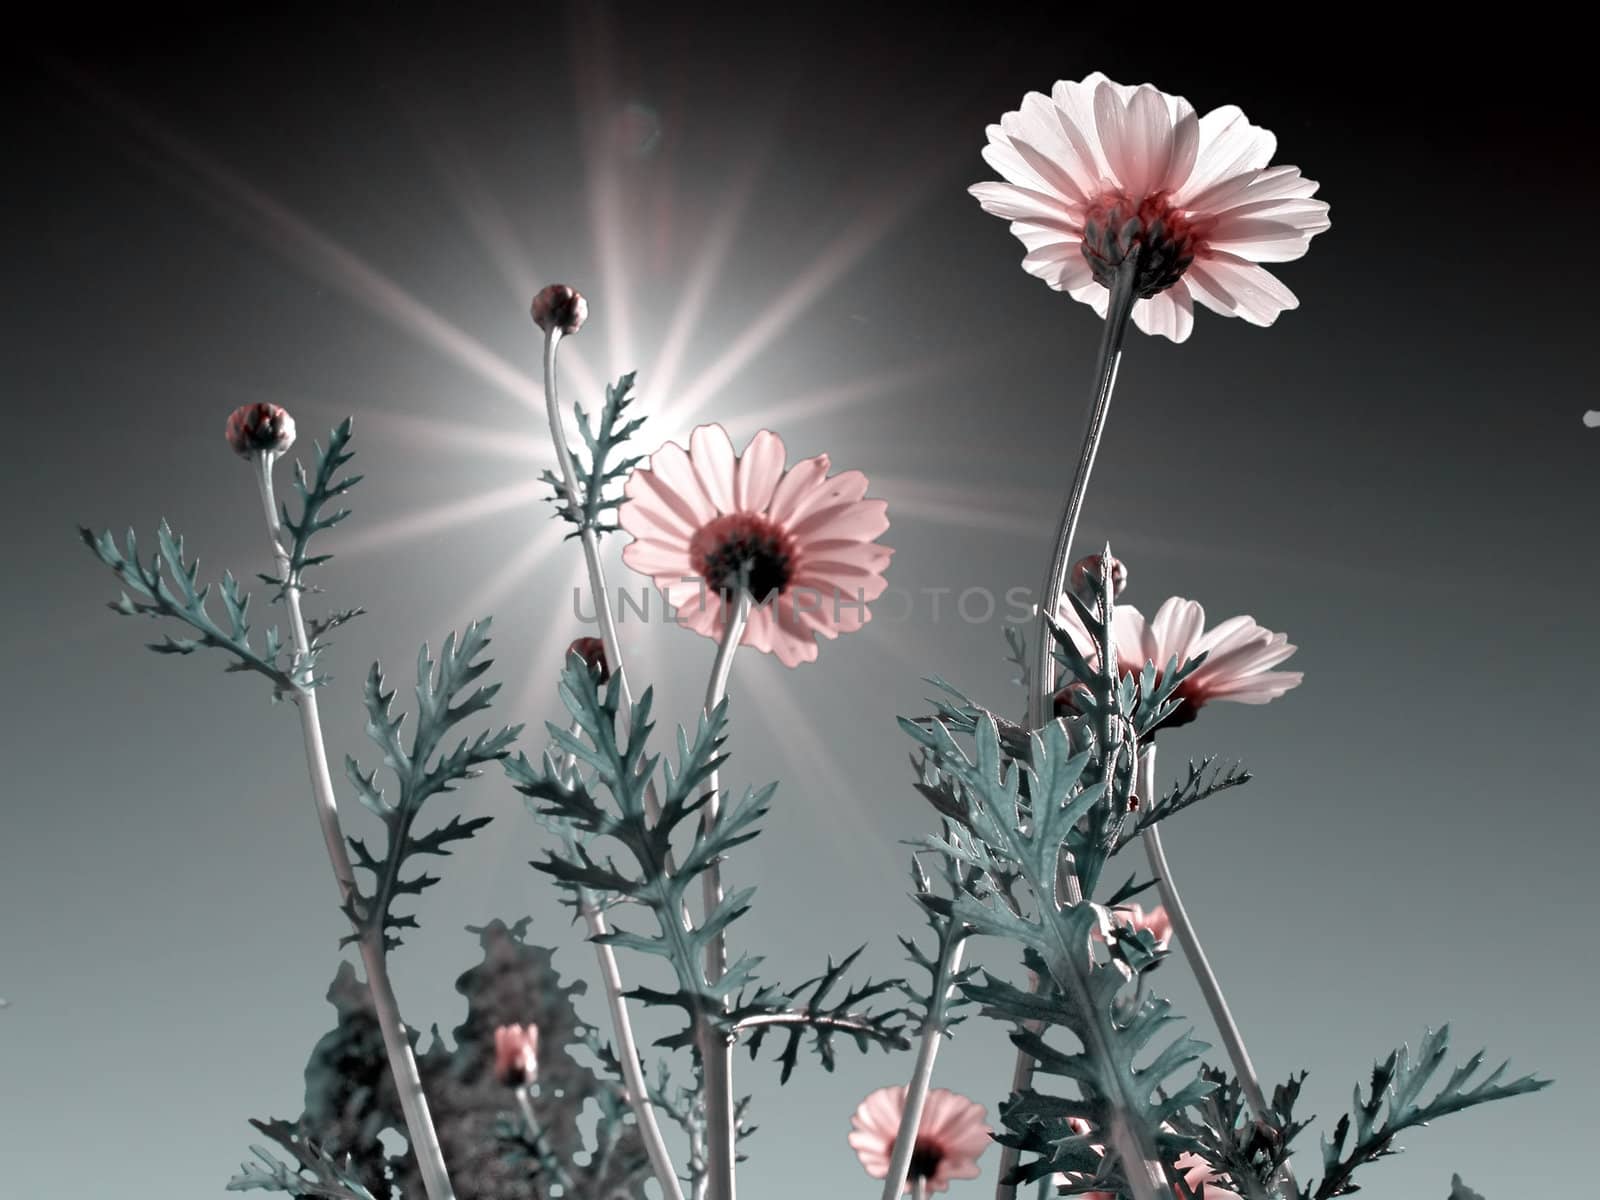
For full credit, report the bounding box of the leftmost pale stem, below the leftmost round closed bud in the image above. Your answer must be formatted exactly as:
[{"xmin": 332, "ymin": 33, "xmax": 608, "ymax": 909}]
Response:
[{"xmin": 256, "ymin": 454, "xmax": 454, "ymax": 1200}]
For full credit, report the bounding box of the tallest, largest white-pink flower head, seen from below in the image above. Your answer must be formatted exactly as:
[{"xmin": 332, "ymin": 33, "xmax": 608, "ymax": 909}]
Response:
[{"xmin": 970, "ymin": 72, "xmax": 1328, "ymax": 342}]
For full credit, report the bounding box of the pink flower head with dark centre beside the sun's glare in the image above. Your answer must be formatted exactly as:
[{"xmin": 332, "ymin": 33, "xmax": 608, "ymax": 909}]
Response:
[{"xmin": 618, "ymin": 426, "xmax": 893, "ymax": 667}]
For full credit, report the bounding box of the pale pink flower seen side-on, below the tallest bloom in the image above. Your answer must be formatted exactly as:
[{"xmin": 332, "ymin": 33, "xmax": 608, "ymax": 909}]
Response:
[{"xmin": 1056, "ymin": 595, "xmax": 1304, "ymax": 730}]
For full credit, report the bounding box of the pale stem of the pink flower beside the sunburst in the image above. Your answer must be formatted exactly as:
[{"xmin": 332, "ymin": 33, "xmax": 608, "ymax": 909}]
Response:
[{"xmin": 696, "ymin": 587, "xmax": 750, "ymax": 1200}]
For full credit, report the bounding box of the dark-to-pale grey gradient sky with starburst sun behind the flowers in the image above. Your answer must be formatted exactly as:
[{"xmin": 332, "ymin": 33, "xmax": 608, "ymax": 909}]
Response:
[{"xmin": 0, "ymin": 16, "xmax": 1600, "ymax": 1200}]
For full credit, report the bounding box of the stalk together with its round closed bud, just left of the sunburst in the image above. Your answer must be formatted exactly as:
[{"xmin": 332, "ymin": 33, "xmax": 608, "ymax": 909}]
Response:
[{"xmin": 533, "ymin": 285, "xmax": 683, "ymax": 1200}]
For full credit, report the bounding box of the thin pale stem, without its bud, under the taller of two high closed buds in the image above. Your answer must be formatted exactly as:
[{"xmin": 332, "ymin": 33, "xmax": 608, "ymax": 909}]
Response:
[{"xmin": 544, "ymin": 325, "xmax": 683, "ymax": 1200}]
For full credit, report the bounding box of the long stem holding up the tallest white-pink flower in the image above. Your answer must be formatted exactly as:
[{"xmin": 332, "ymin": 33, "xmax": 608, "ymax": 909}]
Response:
[{"xmin": 995, "ymin": 254, "xmax": 1139, "ymax": 1200}]
